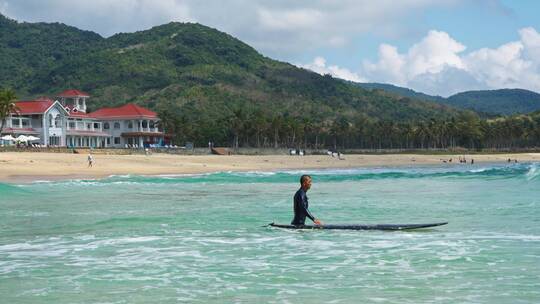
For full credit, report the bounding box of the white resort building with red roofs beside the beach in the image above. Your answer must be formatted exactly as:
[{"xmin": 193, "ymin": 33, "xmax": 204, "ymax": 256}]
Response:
[{"xmin": 1, "ymin": 90, "xmax": 164, "ymax": 148}]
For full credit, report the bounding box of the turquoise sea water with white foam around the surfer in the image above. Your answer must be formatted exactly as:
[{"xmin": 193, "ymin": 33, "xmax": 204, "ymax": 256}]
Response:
[{"xmin": 0, "ymin": 164, "xmax": 540, "ymax": 303}]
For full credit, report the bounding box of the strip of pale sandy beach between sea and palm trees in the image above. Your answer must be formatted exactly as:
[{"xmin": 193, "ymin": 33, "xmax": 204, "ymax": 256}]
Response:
[{"xmin": 0, "ymin": 152, "xmax": 540, "ymax": 183}]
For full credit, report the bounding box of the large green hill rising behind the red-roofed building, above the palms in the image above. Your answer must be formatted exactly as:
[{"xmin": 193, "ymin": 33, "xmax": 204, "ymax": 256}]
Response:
[{"xmin": 0, "ymin": 16, "xmax": 464, "ymax": 145}]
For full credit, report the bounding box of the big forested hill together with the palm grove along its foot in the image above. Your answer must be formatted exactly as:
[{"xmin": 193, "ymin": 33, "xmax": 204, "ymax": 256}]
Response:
[{"xmin": 0, "ymin": 15, "xmax": 540, "ymax": 149}]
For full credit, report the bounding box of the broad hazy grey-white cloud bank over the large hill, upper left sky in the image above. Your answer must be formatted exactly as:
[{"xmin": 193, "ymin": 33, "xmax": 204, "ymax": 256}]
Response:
[{"xmin": 0, "ymin": 0, "xmax": 463, "ymax": 54}]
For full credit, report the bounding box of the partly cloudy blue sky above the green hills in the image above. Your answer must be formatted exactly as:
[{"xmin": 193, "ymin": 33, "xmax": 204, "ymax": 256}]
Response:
[{"xmin": 0, "ymin": 0, "xmax": 540, "ymax": 96}]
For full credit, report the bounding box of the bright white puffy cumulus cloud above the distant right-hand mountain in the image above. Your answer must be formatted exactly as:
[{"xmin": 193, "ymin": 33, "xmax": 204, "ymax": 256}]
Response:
[{"xmin": 362, "ymin": 27, "xmax": 540, "ymax": 96}]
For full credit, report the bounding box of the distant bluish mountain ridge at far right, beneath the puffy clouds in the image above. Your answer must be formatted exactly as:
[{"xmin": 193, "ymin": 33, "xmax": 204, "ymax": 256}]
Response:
[{"xmin": 356, "ymin": 83, "xmax": 540, "ymax": 115}]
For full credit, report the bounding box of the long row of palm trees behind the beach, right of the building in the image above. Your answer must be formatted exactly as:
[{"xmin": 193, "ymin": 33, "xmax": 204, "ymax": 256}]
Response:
[{"xmin": 160, "ymin": 108, "xmax": 540, "ymax": 150}]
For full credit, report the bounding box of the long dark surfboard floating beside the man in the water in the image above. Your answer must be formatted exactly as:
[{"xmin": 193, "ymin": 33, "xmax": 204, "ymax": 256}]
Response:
[{"xmin": 268, "ymin": 222, "xmax": 448, "ymax": 230}]
